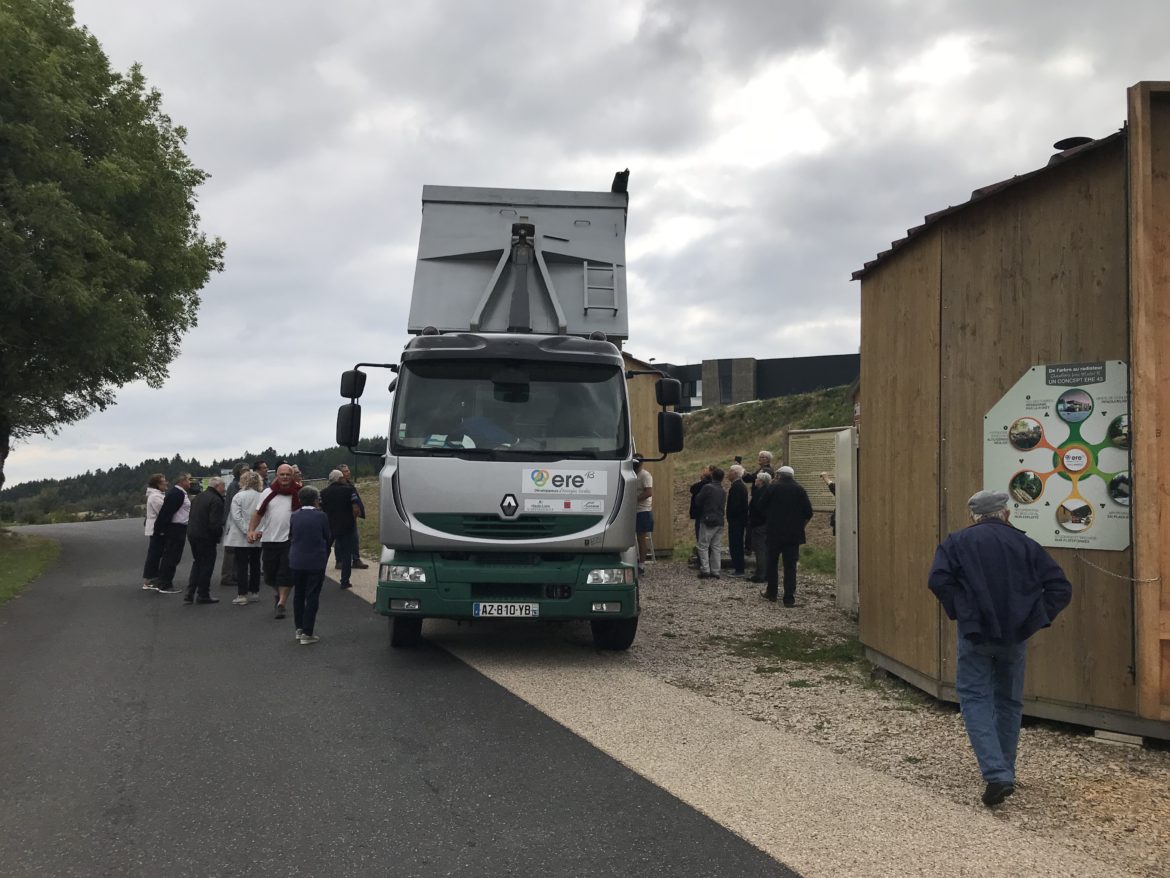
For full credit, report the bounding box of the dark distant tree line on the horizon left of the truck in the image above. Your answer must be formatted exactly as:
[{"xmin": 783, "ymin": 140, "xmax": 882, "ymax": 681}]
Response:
[{"xmin": 0, "ymin": 437, "xmax": 386, "ymax": 524}]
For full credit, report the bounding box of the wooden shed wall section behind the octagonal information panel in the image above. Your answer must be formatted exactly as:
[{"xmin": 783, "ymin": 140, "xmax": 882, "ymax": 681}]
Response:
[{"xmin": 938, "ymin": 139, "xmax": 1135, "ymax": 712}]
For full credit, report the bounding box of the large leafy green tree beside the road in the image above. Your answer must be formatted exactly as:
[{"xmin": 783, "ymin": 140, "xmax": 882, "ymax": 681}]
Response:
[{"xmin": 0, "ymin": 0, "xmax": 223, "ymax": 486}]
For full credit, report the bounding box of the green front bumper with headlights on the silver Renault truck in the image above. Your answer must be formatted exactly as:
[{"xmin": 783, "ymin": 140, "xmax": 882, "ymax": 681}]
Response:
[{"xmin": 374, "ymin": 551, "xmax": 640, "ymax": 619}]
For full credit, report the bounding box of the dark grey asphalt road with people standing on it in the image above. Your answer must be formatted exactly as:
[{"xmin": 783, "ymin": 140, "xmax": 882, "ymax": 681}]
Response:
[{"xmin": 0, "ymin": 521, "xmax": 794, "ymax": 877}]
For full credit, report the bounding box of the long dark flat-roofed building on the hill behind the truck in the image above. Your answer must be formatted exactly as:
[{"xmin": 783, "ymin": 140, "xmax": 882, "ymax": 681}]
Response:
[{"xmin": 658, "ymin": 354, "xmax": 861, "ymax": 411}]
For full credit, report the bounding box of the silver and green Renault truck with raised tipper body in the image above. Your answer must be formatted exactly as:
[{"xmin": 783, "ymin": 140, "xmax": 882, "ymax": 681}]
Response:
[{"xmin": 337, "ymin": 171, "xmax": 683, "ymax": 650}]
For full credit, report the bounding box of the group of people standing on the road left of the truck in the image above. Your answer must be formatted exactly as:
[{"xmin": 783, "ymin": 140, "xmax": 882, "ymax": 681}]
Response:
[{"xmin": 143, "ymin": 460, "xmax": 367, "ymax": 645}]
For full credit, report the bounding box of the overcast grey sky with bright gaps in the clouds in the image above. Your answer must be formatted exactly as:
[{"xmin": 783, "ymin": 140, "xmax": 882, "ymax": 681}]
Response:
[{"xmin": 6, "ymin": 0, "xmax": 1170, "ymax": 485}]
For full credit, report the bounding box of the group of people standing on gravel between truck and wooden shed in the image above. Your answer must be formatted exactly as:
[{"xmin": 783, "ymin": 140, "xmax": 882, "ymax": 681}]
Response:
[{"xmin": 690, "ymin": 451, "xmax": 812, "ymax": 606}]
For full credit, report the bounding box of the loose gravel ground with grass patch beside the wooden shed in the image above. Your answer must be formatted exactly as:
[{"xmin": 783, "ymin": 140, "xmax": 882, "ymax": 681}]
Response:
[{"xmin": 628, "ymin": 557, "xmax": 1170, "ymax": 878}]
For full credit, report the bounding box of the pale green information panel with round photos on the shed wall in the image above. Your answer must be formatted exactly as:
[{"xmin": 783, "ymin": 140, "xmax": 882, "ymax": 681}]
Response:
[{"xmin": 983, "ymin": 359, "xmax": 1130, "ymax": 550}]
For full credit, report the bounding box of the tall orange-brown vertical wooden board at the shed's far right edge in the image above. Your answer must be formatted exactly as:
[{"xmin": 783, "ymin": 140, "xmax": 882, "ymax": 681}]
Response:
[{"xmin": 1129, "ymin": 82, "xmax": 1170, "ymax": 720}]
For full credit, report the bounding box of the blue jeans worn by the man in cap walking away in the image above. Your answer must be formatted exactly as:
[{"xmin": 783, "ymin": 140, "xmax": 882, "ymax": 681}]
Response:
[{"xmin": 955, "ymin": 637, "xmax": 1027, "ymax": 783}]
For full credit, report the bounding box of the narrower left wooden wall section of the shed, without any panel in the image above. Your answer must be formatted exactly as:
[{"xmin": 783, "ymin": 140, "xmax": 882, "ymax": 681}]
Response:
[{"xmin": 858, "ymin": 231, "xmax": 941, "ymax": 679}]
